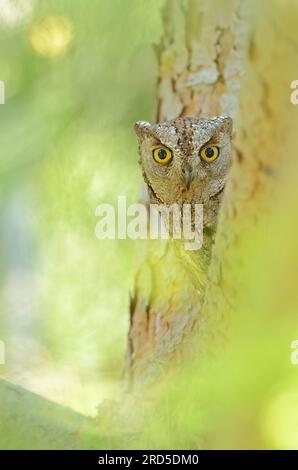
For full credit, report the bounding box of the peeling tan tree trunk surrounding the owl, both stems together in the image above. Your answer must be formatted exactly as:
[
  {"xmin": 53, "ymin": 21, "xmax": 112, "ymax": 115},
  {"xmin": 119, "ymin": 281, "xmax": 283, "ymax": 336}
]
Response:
[{"xmin": 125, "ymin": 0, "xmax": 295, "ymax": 390}]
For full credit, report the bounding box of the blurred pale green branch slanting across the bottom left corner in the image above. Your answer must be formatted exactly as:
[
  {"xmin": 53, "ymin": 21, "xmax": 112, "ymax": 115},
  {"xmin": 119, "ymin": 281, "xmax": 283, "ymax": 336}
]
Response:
[{"xmin": 0, "ymin": 379, "xmax": 98, "ymax": 449}]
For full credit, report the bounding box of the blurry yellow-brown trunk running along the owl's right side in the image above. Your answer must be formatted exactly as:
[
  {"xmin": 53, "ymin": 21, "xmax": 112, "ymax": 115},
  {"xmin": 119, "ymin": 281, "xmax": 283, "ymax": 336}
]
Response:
[{"xmin": 198, "ymin": 0, "xmax": 298, "ymax": 353}]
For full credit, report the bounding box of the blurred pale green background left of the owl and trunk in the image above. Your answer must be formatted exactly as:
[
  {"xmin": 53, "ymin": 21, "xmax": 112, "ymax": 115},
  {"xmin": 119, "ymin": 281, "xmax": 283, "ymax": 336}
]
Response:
[{"xmin": 0, "ymin": 0, "xmax": 162, "ymax": 415}]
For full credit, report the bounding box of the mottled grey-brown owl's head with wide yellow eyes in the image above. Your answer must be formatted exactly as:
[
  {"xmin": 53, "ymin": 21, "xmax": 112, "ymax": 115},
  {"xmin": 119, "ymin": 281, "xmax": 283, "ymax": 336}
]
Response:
[{"xmin": 135, "ymin": 116, "xmax": 233, "ymax": 204}]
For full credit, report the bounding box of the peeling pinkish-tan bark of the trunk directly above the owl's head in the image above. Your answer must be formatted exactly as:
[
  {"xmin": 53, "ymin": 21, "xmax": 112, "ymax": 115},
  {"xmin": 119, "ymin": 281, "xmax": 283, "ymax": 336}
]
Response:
[{"xmin": 157, "ymin": 0, "xmax": 248, "ymax": 121}]
